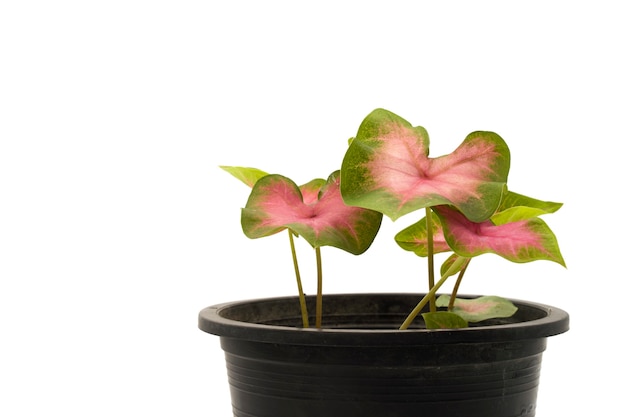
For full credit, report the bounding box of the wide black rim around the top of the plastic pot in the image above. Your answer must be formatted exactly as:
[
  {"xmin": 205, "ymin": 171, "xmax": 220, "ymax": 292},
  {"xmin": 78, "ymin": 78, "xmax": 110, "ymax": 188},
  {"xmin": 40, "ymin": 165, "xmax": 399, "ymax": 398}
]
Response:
[{"xmin": 198, "ymin": 293, "xmax": 569, "ymax": 347}]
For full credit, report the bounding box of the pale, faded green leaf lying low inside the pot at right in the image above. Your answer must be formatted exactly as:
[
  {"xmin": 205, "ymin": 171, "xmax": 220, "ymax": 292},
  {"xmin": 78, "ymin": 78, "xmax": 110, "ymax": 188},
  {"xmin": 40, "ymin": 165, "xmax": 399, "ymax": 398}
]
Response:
[{"xmin": 436, "ymin": 295, "xmax": 517, "ymax": 323}]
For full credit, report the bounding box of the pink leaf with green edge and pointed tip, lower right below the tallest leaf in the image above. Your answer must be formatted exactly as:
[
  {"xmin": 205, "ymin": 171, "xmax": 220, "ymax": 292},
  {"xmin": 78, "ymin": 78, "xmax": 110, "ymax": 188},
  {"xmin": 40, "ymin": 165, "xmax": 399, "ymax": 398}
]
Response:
[{"xmin": 433, "ymin": 206, "xmax": 565, "ymax": 266}]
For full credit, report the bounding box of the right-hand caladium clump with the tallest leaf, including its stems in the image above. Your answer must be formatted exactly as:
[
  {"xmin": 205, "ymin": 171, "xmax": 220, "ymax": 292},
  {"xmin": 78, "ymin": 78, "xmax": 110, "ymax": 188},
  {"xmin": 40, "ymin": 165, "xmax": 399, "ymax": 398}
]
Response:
[{"xmin": 341, "ymin": 109, "xmax": 565, "ymax": 329}]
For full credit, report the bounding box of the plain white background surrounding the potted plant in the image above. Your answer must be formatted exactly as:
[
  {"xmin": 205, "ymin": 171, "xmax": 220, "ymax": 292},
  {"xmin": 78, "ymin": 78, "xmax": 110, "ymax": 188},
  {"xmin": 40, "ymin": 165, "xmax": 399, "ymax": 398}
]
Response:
[{"xmin": 0, "ymin": 0, "xmax": 626, "ymax": 417}]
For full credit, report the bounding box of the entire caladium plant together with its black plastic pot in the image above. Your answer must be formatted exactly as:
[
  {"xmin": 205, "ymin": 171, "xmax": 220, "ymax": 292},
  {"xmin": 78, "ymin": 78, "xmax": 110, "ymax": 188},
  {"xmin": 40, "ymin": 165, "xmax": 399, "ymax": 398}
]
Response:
[{"xmin": 199, "ymin": 109, "xmax": 569, "ymax": 417}]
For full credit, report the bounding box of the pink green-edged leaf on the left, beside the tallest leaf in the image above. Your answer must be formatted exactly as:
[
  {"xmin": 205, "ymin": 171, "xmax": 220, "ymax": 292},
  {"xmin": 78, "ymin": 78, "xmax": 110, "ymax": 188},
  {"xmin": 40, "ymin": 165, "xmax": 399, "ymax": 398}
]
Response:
[{"xmin": 241, "ymin": 171, "xmax": 382, "ymax": 254}]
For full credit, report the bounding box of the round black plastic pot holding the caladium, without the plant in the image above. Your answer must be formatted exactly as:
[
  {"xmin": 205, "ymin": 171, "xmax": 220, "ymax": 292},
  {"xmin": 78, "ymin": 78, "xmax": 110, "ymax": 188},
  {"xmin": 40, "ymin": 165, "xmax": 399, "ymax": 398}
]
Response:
[{"xmin": 198, "ymin": 294, "xmax": 569, "ymax": 417}]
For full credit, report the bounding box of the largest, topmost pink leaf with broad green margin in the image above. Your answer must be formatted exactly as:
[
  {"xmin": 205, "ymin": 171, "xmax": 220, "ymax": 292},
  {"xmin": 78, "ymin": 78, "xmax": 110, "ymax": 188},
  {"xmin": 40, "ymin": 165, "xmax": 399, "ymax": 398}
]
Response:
[{"xmin": 341, "ymin": 109, "xmax": 510, "ymax": 221}]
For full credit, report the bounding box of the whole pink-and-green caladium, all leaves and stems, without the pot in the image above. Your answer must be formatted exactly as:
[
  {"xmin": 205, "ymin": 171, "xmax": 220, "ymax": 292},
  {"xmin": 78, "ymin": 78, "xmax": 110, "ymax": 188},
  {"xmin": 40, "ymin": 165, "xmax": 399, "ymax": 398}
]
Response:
[{"xmin": 222, "ymin": 109, "xmax": 565, "ymax": 329}]
